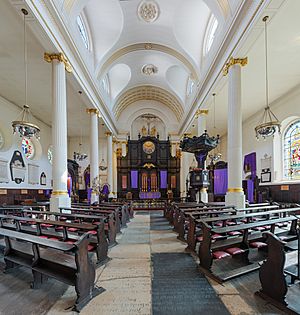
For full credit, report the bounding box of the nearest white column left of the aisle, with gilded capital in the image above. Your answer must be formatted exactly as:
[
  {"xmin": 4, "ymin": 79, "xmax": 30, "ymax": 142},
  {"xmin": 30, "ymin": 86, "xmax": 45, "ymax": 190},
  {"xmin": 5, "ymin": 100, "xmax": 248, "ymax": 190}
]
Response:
[{"xmin": 44, "ymin": 53, "xmax": 72, "ymax": 211}]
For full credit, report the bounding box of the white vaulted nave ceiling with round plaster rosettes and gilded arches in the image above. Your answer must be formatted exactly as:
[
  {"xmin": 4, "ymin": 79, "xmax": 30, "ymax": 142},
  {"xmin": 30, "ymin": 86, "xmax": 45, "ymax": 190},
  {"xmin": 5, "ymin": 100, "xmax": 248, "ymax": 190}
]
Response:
[{"xmin": 57, "ymin": 0, "xmax": 242, "ymax": 135}]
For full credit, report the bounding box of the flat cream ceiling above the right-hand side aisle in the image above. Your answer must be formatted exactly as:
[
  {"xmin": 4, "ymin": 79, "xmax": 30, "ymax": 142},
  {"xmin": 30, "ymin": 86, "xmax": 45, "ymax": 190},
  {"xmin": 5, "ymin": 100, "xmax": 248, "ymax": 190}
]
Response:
[{"xmin": 189, "ymin": 0, "xmax": 300, "ymax": 135}]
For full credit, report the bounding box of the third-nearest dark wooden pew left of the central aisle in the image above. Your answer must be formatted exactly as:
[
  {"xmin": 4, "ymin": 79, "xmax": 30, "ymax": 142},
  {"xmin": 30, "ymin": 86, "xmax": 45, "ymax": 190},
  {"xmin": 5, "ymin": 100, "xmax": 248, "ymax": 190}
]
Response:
[{"xmin": 23, "ymin": 210, "xmax": 117, "ymax": 247}]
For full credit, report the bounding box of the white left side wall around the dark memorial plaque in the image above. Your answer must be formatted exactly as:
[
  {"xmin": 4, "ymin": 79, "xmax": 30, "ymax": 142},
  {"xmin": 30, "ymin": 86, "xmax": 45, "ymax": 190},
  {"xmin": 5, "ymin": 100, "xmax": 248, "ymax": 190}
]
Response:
[{"xmin": 0, "ymin": 96, "xmax": 52, "ymax": 189}]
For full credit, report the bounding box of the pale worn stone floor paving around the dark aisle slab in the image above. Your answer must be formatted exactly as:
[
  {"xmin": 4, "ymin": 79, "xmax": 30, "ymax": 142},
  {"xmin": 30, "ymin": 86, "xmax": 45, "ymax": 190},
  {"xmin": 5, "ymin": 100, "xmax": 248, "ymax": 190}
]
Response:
[{"xmin": 47, "ymin": 211, "xmax": 284, "ymax": 315}]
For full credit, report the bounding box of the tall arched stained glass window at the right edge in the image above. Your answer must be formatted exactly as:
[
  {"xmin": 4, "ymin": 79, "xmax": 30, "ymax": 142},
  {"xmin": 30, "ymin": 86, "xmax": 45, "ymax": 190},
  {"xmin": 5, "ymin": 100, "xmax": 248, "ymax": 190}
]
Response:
[{"xmin": 283, "ymin": 120, "xmax": 300, "ymax": 180}]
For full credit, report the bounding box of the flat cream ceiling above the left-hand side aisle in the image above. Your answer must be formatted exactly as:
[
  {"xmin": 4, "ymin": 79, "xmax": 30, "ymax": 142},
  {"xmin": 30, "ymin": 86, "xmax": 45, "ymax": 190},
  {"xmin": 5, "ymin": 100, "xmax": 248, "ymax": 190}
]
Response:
[{"xmin": 0, "ymin": 1, "xmax": 105, "ymax": 137}]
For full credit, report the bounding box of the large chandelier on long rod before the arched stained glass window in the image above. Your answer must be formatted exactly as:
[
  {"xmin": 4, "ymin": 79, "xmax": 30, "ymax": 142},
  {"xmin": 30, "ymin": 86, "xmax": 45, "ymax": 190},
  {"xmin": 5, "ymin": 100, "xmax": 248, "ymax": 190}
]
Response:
[{"xmin": 255, "ymin": 16, "xmax": 280, "ymax": 140}]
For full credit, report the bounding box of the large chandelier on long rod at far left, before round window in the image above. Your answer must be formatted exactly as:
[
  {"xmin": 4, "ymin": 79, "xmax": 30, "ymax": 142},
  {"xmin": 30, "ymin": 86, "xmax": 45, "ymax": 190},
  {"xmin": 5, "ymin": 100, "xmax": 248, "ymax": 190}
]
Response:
[{"xmin": 11, "ymin": 9, "xmax": 40, "ymax": 139}]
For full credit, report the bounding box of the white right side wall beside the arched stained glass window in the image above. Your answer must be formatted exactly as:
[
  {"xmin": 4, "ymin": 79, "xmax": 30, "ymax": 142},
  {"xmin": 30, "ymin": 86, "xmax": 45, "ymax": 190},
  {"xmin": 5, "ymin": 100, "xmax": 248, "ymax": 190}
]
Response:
[{"xmin": 220, "ymin": 86, "xmax": 300, "ymax": 181}]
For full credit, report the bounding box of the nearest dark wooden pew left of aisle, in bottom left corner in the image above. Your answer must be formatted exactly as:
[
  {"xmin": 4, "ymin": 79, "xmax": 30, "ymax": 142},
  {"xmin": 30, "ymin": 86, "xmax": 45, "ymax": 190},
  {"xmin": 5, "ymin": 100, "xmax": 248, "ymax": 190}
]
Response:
[{"xmin": 0, "ymin": 228, "xmax": 104, "ymax": 312}]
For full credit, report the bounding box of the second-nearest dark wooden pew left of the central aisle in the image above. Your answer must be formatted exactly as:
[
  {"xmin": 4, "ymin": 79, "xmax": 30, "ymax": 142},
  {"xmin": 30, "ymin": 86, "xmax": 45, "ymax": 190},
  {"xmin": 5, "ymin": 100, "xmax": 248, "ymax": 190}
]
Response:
[{"xmin": 0, "ymin": 214, "xmax": 109, "ymax": 266}]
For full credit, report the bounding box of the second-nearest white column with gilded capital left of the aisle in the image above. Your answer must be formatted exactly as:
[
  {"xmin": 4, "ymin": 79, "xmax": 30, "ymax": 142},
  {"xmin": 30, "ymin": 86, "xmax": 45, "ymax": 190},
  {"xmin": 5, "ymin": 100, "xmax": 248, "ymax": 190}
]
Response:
[{"xmin": 87, "ymin": 108, "xmax": 99, "ymax": 203}]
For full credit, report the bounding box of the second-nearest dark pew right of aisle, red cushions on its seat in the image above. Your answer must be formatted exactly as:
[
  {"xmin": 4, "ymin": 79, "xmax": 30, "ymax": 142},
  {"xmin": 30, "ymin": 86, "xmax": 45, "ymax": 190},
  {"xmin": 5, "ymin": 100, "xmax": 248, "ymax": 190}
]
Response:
[{"xmin": 199, "ymin": 215, "xmax": 297, "ymax": 282}]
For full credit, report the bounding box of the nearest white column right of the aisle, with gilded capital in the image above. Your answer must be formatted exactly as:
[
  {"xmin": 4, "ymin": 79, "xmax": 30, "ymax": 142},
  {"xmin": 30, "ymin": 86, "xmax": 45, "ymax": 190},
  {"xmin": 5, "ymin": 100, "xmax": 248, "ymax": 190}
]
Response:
[{"xmin": 224, "ymin": 58, "xmax": 247, "ymax": 208}]
